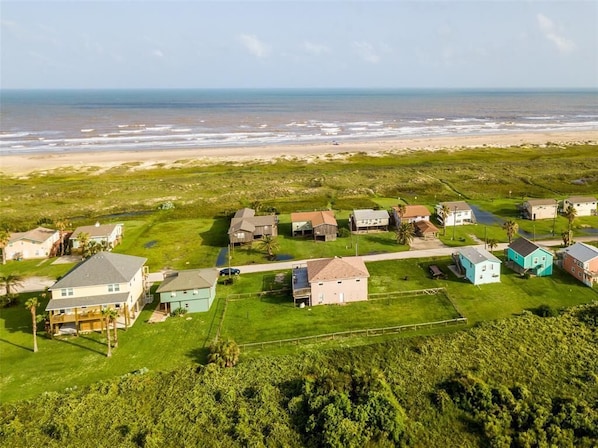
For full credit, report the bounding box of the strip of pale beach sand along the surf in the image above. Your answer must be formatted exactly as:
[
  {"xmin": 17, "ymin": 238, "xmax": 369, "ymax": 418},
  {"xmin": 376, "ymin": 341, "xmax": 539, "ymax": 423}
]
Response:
[{"xmin": 0, "ymin": 131, "xmax": 598, "ymax": 175}]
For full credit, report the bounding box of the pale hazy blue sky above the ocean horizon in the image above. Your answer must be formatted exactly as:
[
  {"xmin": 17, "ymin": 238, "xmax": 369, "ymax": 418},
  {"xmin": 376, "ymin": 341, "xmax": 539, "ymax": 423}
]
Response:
[{"xmin": 0, "ymin": 0, "xmax": 598, "ymax": 89}]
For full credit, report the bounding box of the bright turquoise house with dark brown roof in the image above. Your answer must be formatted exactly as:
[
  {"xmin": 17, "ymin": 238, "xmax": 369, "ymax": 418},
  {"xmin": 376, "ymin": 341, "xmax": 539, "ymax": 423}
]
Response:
[{"xmin": 506, "ymin": 237, "xmax": 554, "ymax": 277}]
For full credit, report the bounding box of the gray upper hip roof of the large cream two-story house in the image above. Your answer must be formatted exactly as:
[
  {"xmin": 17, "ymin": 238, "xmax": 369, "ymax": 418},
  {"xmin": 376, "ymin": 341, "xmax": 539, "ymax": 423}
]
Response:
[{"xmin": 50, "ymin": 252, "xmax": 147, "ymax": 290}]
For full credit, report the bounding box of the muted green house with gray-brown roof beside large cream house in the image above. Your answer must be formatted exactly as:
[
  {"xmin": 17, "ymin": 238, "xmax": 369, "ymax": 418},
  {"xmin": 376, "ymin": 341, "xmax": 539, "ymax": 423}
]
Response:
[{"xmin": 156, "ymin": 269, "xmax": 218, "ymax": 313}]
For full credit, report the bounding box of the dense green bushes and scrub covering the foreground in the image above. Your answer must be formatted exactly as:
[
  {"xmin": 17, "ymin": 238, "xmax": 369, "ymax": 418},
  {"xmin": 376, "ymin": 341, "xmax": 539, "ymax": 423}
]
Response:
[{"xmin": 0, "ymin": 304, "xmax": 598, "ymax": 447}]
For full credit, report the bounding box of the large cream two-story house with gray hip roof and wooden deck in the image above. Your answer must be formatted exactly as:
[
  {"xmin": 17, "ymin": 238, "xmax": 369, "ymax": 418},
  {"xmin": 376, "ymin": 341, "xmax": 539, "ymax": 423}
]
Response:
[{"xmin": 46, "ymin": 252, "xmax": 150, "ymax": 333}]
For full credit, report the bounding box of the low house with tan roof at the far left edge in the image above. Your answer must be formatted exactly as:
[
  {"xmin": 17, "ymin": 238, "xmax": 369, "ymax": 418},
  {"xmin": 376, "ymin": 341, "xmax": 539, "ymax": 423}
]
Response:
[{"xmin": 4, "ymin": 227, "xmax": 60, "ymax": 260}]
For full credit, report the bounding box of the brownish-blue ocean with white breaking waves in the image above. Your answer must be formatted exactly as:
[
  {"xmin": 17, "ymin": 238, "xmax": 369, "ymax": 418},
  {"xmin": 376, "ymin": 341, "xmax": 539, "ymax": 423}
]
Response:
[{"xmin": 0, "ymin": 89, "xmax": 598, "ymax": 154}]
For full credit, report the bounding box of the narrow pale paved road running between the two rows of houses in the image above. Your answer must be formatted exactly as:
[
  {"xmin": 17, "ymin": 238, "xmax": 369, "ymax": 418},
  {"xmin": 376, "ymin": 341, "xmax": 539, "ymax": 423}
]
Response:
[{"xmin": 14, "ymin": 236, "xmax": 598, "ymax": 293}]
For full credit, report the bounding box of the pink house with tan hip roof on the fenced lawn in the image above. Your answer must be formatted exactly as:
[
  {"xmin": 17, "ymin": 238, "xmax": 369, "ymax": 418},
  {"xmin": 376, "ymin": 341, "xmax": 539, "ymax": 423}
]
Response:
[{"xmin": 292, "ymin": 257, "xmax": 370, "ymax": 306}]
